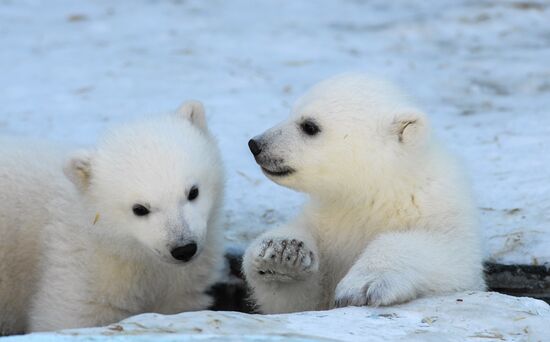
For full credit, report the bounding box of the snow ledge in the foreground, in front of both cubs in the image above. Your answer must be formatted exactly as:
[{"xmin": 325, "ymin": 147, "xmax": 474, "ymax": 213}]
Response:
[{"xmin": 3, "ymin": 292, "xmax": 550, "ymax": 342}]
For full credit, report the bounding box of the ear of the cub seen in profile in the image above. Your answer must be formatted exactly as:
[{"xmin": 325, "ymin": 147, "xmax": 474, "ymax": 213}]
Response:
[{"xmin": 392, "ymin": 111, "xmax": 428, "ymax": 145}]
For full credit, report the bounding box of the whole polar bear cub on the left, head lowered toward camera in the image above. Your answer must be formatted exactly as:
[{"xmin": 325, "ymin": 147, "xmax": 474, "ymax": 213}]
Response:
[{"xmin": 0, "ymin": 102, "xmax": 223, "ymax": 334}]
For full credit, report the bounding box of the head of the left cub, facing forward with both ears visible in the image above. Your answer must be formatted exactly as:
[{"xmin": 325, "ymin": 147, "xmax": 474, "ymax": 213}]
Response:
[{"xmin": 65, "ymin": 101, "xmax": 223, "ymax": 263}]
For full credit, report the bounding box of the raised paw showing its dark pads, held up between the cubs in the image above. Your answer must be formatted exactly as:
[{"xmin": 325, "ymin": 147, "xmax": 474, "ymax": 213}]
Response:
[{"xmin": 246, "ymin": 238, "xmax": 318, "ymax": 282}]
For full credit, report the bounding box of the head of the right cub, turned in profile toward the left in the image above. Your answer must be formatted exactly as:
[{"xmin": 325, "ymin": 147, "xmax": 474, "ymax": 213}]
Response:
[{"xmin": 249, "ymin": 74, "xmax": 436, "ymax": 198}]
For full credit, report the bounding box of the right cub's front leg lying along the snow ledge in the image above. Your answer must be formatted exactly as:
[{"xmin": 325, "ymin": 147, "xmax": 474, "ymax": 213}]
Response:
[{"xmin": 335, "ymin": 231, "xmax": 485, "ymax": 307}]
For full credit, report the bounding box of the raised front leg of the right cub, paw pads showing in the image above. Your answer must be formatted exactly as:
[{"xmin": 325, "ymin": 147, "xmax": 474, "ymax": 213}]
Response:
[{"xmin": 243, "ymin": 223, "xmax": 321, "ymax": 313}]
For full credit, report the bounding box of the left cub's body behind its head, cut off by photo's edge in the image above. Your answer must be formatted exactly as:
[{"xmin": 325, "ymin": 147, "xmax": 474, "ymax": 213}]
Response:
[{"xmin": 0, "ymin": 137, "xmax": 73, "ymax": 335}]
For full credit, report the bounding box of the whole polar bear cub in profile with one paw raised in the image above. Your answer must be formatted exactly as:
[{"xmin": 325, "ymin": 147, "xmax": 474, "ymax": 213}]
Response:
[{"xmin": 243, "ymin": 74, "xmax": 485, "ymax": 313}]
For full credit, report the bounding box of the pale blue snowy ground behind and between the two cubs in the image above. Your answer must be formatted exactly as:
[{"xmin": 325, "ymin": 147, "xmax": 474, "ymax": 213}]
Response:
[{"xmin": 0, "ymin": 0, "xmax": 550, "ymax": 264}]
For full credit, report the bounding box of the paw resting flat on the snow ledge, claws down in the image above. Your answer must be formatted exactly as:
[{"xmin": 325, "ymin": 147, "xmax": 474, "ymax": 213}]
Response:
[{"xmin": 334, "ymin": 271, "xmax": 416, "ymax": 307}]
